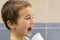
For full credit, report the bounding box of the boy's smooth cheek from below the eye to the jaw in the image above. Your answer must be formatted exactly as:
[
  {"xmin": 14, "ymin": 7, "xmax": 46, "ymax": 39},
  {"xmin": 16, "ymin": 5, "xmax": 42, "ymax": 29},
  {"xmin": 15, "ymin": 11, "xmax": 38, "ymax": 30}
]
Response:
[{"xmin": 16, "ymin": 20, "xmax": 29, "ymax": 34}]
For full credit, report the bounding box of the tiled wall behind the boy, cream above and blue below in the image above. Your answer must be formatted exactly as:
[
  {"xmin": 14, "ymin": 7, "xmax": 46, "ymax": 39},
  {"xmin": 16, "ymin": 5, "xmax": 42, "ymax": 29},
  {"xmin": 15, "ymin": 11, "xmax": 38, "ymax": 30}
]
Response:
[{"xmin": 0, "ymin": 0, "xmax": 60, "ymax": 40}]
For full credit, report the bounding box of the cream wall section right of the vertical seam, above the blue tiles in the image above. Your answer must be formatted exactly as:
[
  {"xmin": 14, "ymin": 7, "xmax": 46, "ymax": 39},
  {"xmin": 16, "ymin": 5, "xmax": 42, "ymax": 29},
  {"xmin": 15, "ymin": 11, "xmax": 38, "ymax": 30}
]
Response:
[{"xmin": 47, "ymin": 0, "xmax": 60, "ymax": 23}]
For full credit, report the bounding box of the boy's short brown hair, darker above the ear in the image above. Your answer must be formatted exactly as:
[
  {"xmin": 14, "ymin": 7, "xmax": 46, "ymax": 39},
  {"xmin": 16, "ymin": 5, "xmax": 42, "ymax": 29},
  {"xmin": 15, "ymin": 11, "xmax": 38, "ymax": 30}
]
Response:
[{"xmin": 1, "ymin": 1, "xmax": 31, "ymax": 29}]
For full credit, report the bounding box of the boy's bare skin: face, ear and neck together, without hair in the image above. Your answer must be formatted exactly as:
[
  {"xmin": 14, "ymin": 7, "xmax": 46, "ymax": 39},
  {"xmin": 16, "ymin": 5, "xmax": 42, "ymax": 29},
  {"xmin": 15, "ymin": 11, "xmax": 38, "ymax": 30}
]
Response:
[{"xmin": 7, "ymin": 7, "xmax": 34, "ymax": 40}]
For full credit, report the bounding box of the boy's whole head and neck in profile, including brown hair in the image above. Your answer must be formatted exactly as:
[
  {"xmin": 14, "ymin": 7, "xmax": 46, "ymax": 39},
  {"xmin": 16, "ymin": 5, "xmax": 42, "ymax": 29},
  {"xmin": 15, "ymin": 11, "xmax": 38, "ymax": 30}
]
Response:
[{"xmin": 1, "ymin": 0, "xmax": 34, "ymax": 40}]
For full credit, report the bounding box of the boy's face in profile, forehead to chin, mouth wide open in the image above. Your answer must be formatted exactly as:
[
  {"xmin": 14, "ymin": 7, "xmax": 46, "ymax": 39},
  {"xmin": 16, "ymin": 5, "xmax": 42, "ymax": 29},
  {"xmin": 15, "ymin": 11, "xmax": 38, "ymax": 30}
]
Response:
[{"xmin": 15, "ymin": 7, "xmax": 34, "ymax": 36}]
